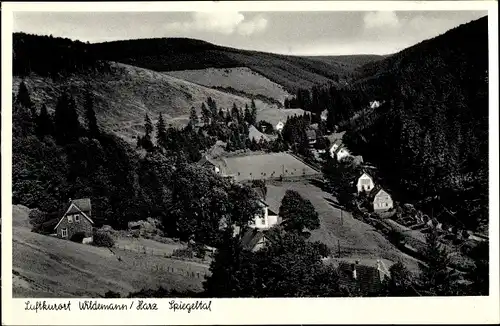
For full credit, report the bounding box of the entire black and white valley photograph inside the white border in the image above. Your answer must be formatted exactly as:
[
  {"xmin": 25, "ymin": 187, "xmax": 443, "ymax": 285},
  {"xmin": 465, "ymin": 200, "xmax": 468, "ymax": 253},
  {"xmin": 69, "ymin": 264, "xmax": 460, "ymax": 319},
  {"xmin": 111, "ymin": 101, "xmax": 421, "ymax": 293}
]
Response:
[{"xmin": 2, "ymin": 0, "xmax": 498, "ymax": 314}]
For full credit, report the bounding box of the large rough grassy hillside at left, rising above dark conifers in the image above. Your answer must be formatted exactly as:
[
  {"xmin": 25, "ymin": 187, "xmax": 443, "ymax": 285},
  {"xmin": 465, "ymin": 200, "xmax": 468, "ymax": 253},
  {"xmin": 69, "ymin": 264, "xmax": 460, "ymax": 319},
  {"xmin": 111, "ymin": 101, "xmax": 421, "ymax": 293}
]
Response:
[{"xmin": 13, "ymin": 64, "xmax": 275, "ymax": 142}]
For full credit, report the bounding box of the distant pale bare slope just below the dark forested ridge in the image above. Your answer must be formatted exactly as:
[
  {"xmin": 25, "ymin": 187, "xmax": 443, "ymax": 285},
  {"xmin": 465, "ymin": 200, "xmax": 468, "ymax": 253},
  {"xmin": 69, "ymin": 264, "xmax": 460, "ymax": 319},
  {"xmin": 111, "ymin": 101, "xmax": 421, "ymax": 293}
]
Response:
[{"xmin": 166, "ymin": 67, "xmax": 290, "ymax": 103}]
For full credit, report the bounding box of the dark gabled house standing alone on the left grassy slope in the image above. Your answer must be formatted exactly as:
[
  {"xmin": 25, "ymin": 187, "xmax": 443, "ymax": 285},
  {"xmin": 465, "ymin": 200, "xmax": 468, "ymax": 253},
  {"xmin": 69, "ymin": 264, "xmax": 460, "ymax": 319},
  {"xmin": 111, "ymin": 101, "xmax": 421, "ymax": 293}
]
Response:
[{"xmin": 54, "ymin": 198, "xmax": 94, "ymax": 243}]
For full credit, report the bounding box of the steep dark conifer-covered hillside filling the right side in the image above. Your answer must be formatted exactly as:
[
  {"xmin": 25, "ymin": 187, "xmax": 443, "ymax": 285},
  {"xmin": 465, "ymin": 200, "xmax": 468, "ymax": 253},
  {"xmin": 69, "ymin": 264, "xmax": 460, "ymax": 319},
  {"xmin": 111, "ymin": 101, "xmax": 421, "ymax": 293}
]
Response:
[{"xmin": 297, "ymin": 17, "xmax": 488, "ymax": 232}]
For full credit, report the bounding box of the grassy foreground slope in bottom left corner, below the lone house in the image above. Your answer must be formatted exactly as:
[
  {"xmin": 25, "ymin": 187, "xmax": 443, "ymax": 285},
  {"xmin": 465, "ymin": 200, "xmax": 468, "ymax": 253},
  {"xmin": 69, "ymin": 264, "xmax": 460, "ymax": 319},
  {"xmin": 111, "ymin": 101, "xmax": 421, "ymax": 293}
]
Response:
[{"xmin": 12, "ymin": 206, "xmax": 207, "ymax": 297}]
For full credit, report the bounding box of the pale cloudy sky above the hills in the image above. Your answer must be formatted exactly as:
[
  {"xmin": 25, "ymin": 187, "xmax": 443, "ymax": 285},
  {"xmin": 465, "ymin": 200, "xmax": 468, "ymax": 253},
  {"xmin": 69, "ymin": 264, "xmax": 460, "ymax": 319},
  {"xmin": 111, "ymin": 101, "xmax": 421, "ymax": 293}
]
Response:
[{"xmin": 14, "ymin": 11, "xmax": 487, "ymax": 55}]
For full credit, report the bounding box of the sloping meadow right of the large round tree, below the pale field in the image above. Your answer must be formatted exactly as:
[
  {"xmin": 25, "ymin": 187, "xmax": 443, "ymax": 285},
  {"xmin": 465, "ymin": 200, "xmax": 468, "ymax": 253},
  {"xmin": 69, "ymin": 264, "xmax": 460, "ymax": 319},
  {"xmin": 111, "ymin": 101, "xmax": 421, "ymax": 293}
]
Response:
[{"xmin": 266, "ymin": 182, "xmax": 418, "ymax": 271}]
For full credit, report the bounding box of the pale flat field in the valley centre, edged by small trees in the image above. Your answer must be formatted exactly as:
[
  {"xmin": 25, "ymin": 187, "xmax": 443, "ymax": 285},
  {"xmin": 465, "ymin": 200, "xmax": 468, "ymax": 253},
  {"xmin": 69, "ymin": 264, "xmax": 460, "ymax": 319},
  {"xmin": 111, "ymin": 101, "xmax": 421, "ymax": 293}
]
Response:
[{"xmin": 219, "ymin": 153, "xmax": 319, "ymax": 181}]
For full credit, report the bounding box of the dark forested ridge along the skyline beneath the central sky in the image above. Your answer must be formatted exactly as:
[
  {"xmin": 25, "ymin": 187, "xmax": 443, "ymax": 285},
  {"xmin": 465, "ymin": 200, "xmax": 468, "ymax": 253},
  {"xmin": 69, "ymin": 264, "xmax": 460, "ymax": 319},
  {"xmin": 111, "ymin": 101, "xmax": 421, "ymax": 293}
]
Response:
[{"xmin": 91, "ymin": 38, "xmax": 356, "ymax": 92}]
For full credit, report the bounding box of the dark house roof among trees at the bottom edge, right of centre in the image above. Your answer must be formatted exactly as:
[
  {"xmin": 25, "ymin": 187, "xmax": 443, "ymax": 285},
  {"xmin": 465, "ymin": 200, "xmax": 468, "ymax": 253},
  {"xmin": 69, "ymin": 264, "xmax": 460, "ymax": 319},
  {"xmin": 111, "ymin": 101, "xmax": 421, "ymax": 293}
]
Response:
[{"xmin": 338, "ymin": 262, "xmax": 382, "ymax": 294}]
